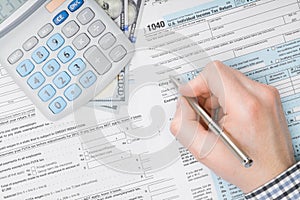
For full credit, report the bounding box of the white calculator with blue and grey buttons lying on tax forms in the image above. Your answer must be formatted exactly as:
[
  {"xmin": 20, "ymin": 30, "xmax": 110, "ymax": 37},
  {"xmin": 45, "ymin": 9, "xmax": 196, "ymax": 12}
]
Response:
[{"xmin": 0, "ymin": 0, "xmax": 134, "ymax": 120}]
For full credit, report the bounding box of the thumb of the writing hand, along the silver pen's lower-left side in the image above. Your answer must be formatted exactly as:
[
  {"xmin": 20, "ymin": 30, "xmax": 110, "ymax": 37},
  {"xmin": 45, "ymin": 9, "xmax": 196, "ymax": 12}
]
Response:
[{"xmin": 171, "ymin": 95, "xmax": 244, "ymax": 170}]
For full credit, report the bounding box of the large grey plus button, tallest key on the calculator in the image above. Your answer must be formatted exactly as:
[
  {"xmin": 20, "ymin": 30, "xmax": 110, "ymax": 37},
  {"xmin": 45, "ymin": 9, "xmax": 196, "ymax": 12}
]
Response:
[{"xmin": 83, "ymin": 46, "xmax": 112, "ymax": 75}]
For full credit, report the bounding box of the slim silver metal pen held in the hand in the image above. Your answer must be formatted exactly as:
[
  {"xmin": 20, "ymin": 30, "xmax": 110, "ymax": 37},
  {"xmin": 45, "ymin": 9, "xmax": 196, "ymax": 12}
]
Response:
[{"xmin": 170, "ymin": 76, "xmax": 253, "ymax": 168}]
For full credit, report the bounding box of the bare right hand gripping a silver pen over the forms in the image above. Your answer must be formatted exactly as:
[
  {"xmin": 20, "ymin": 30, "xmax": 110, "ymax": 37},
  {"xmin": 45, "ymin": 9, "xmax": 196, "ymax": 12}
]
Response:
[{"xmin": 171, "ymin": 61, "xmax": 295, "ymax": 193}]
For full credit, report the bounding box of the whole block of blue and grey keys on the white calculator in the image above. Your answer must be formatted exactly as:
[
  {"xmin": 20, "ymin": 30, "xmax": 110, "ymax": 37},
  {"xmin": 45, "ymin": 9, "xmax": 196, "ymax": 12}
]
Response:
[{"xmin": 7, "ymin": 0, "xmax": 131, "ymax": 117}]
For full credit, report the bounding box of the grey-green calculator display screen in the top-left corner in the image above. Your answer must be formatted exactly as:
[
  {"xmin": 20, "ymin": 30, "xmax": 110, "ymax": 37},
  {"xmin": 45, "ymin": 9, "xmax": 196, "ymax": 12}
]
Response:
[{"xmin": 0, "ymin": 0, "xmax": 27, "ymax": 24}]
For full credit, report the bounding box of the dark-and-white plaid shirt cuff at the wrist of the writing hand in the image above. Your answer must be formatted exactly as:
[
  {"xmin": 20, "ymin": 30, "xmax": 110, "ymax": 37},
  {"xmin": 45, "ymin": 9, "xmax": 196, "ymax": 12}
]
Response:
[{"xmin": 245, "ymin": 162, "xmax": 300, "ymax": 200}]
